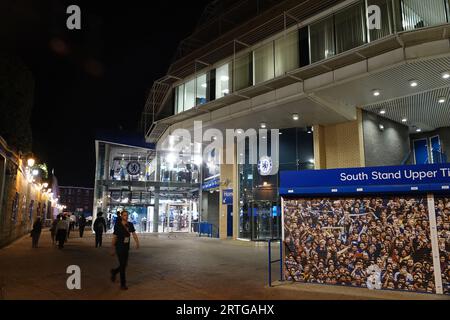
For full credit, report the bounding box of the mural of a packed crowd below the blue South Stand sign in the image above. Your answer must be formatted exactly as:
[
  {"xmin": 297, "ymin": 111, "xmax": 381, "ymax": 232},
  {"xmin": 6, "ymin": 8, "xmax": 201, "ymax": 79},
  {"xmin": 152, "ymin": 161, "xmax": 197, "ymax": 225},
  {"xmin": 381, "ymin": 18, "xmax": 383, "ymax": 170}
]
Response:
[{"xmin": 284, "ymin": 196, "xmax": 450, "ymax": 294}]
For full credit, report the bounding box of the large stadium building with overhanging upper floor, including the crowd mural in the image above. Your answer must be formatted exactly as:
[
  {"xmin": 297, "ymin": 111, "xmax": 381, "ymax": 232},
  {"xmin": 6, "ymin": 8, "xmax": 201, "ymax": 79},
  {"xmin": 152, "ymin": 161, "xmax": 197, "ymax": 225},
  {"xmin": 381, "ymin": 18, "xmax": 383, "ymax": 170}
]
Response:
[{"xmin": 136, "ymin": 0, "xmax": 450, "ymax": 293}]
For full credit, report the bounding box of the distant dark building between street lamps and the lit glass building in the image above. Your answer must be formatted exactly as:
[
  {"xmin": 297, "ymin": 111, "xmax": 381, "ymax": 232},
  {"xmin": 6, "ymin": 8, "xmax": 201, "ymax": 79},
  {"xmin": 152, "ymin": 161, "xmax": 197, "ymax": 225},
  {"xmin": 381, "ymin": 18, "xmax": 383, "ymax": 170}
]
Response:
[{"xmin": 59, "ymin": 186, "xmax": 94, "ymax": 216}]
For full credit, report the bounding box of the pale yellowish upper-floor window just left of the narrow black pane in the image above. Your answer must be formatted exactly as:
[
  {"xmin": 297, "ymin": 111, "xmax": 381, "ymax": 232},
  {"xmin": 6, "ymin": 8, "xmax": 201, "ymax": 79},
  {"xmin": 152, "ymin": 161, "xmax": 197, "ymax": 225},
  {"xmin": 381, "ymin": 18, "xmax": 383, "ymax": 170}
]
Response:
[{"xmin": 275, "ymin": 31, "xmax": 299, "ymax": 77}]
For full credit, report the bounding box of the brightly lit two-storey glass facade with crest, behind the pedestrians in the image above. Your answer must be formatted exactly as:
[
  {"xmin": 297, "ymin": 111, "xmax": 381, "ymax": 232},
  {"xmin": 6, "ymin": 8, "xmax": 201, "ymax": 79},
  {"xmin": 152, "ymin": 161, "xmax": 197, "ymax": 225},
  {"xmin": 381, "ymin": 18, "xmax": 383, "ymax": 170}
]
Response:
[{"xmin": 94, "ymin": 141, "xmax": 199, "ymax": 232}]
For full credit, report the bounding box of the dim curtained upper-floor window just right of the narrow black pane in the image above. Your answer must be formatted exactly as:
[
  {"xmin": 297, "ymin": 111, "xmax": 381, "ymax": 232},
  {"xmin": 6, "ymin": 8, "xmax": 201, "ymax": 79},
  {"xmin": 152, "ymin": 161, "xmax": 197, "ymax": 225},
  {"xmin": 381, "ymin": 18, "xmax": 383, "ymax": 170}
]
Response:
[{"xmin": 309, "ymin": 16, "xmax": 335, "ymax": 63}]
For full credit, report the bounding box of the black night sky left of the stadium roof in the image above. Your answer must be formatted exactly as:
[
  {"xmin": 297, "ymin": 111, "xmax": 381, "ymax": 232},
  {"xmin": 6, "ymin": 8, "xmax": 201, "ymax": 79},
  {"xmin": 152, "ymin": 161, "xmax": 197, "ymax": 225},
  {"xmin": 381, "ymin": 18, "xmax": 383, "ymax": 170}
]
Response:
[{"xmin": 0, "ymin": 0, "xmax": 210, "ymax": 187}]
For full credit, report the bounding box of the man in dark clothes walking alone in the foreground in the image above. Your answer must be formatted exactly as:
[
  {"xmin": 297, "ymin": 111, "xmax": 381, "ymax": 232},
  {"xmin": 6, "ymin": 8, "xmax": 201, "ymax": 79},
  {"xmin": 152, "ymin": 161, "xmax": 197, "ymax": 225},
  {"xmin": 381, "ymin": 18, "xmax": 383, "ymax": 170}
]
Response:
[{"xmin": 111, "ymin": 211, "xmax": 139, "ymax": 290}]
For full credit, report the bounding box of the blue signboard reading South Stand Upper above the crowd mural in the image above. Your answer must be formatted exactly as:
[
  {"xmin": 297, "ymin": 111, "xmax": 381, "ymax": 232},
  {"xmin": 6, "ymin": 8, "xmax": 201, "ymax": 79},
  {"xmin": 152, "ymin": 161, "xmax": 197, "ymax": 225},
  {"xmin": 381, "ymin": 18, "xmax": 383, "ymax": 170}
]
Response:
[{"xmin": 280, "ymin": 163, "xmax": 450, "ymax": 195}]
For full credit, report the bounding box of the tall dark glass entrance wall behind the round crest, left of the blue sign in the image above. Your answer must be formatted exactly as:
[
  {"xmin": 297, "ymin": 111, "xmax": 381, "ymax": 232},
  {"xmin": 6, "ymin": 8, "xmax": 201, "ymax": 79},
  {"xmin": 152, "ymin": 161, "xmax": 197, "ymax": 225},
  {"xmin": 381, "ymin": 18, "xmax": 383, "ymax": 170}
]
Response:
[{"xmin": 238, "ymin": 128, "xmax": 314, "ymax": 241}]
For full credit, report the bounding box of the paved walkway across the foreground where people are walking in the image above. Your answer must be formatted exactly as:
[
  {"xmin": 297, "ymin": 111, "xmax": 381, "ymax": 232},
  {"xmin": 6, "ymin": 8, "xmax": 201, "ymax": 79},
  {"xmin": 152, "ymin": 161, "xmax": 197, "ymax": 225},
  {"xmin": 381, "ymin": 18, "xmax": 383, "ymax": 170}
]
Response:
[{"xmin": 0, "ymin": 230, "xmax": 448, "ymax": 300}]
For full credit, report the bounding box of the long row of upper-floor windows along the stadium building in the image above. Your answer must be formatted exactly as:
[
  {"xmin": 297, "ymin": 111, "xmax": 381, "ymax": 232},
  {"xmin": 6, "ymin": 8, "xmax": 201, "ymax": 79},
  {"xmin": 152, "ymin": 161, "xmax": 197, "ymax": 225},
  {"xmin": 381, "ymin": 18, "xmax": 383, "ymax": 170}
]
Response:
[{"xmin": 175, "ymin": 0, "xmax": 448, "ymax": 113}]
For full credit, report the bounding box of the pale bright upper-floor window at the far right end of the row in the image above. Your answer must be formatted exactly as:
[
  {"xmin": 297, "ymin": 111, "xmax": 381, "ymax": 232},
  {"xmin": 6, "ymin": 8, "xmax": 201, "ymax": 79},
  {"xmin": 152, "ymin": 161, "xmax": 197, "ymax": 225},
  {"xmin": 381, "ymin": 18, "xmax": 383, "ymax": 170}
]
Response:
[{"xmin": 402, "ymin": 0, "xmax": 447, "ymax": 30}]
